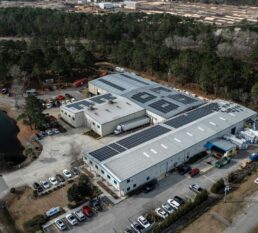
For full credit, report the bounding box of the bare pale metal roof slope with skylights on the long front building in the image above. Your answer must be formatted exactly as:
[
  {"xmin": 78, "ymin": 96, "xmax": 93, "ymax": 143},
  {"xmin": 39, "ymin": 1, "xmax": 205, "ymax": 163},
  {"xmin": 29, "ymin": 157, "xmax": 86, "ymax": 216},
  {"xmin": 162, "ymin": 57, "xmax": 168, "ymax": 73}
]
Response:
[{"xmin": 87, "ymin": 101, "xmax": 256, "ymax": 181}]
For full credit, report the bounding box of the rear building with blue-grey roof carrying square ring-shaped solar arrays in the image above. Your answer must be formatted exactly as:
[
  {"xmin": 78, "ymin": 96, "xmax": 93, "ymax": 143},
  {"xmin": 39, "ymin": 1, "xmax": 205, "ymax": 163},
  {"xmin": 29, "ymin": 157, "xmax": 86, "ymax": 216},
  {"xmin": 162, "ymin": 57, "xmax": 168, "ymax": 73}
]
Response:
[{"xmin": 89, "ymin": 72, "xmax": 203, "ymax": 124}]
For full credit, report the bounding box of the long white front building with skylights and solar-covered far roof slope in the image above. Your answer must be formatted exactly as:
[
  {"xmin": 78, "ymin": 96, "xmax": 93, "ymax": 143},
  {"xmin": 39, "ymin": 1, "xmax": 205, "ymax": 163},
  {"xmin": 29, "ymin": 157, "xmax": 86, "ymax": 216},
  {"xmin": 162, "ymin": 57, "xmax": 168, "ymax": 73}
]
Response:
[{"xmin": 84, "ymin": 100, "xmax": 257, "ymax": 195}]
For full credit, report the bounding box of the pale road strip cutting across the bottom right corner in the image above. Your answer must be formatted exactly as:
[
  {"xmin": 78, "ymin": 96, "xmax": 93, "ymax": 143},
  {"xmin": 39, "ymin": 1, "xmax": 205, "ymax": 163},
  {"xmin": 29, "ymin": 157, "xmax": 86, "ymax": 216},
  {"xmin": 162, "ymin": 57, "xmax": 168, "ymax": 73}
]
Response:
[{"xmin": 224, "ymin": 193, "xmax": 258, "ymax": 233}]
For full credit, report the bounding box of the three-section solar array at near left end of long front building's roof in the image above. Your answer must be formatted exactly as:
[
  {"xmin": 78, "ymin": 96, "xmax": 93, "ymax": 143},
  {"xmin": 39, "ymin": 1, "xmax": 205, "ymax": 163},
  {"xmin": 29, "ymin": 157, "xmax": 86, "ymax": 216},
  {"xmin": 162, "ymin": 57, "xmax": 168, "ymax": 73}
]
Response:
[{"xmin": 89, "ymin": 125, "xmax": 170, "ymax": 162}]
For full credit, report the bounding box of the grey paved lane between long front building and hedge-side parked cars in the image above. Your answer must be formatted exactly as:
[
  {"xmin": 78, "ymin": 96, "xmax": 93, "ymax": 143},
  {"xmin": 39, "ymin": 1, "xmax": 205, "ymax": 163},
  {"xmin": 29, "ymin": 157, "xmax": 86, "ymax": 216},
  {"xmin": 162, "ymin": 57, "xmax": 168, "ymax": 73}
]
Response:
[{"xmin": 63, "ymin": 146, "xmax": 257, "ymax": 233}]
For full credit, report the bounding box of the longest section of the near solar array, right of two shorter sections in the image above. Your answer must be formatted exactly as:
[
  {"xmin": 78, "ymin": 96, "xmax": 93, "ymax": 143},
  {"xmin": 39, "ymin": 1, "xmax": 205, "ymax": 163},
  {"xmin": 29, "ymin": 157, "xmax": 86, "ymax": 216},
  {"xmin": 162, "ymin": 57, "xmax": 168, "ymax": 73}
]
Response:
[{"xmin": 116, "ymin": 125, "xmax": 170, "ymax": 149}]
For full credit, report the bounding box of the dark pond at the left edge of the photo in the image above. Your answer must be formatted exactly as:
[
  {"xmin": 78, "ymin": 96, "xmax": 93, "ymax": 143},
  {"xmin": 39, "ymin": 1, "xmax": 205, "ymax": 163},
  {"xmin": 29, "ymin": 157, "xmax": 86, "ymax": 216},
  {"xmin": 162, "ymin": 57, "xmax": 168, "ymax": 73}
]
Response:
[{"xmin": 0, "ymin": 110, "xmax": 25, "ymax": 165}]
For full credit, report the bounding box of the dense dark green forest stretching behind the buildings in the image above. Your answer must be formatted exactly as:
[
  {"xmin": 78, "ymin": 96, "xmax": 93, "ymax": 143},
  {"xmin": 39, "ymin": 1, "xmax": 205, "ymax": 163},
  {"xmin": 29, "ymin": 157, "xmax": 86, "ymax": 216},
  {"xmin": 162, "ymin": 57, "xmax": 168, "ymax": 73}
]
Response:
[{"xmin": 0, "ymin": 8, "xmax": 258, "ymax": 104}]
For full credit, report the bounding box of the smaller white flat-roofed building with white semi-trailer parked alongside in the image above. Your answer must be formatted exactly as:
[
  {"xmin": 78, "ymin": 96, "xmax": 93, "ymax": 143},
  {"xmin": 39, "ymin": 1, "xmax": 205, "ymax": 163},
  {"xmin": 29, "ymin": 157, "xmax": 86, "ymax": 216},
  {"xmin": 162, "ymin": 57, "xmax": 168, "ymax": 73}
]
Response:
[{"xmin": 60, "ymin": 93, "xmax": 146, "ymax": 136}]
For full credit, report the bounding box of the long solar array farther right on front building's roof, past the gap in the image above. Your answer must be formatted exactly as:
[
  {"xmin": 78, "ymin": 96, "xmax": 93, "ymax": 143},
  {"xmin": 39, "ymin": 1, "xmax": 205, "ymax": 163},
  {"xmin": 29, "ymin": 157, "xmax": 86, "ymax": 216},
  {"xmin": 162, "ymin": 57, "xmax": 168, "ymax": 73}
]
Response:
[{"xmin": 164, "ymin": 103, "xmax": 218, "ymax": 128}]
